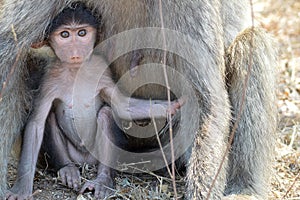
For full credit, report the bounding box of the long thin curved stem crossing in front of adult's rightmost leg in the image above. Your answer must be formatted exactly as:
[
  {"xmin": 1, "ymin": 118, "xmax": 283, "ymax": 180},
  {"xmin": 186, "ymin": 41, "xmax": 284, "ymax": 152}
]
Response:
[{"xmin": 206, "ymin": 0, "xmax": 254, "ymax": 200}]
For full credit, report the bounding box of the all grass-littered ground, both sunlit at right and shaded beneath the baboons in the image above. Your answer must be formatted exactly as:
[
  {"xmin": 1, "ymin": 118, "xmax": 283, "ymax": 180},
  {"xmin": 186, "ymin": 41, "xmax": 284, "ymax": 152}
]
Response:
[{"xmin": 8, "ymin": 0, "xmax": 300, "ymax": 200}]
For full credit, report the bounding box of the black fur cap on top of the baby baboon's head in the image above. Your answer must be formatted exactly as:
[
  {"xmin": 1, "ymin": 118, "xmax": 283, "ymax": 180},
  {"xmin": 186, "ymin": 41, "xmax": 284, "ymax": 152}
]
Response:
[{"xmin": 46, "ymin": 2, "xmax": 98, "ymax": 36}]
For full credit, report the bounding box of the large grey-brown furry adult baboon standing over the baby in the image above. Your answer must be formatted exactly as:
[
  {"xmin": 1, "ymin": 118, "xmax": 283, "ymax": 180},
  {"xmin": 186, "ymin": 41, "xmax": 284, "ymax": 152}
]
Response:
[{"xmin": 0, "ymin": 0, "xmax": 276, "ymax": 199}]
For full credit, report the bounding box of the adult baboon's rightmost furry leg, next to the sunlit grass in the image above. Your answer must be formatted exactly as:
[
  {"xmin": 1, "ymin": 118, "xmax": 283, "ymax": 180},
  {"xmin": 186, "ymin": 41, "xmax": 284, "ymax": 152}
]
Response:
[{"xmin": 225, "ymin": 28, "xmax": 276, "ymax": 199}]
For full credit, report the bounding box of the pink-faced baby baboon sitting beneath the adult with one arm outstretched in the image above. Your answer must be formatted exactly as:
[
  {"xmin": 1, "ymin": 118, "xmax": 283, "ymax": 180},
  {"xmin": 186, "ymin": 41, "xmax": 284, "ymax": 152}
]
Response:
[{"xmin": 6, "ymin": 3, "xmax": 181, "ymax": 200}]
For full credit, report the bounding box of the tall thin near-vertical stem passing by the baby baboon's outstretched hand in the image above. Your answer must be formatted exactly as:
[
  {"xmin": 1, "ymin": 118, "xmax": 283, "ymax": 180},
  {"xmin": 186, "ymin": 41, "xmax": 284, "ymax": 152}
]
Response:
[{"xmin": 159, "ymin": 0, "xmax": 178, "ymax": 199}]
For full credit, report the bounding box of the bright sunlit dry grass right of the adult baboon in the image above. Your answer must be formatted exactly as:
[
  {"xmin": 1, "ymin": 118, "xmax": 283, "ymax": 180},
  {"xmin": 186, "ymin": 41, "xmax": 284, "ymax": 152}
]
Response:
[{"xmin": 255, "ymin": 0, "xmax": 300, "ymax": 199}]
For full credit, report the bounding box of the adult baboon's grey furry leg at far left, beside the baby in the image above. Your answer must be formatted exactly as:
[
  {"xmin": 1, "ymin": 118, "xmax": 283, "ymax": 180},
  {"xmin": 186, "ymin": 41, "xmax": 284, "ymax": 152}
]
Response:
[{"xmin": 0, "ymin": 0, "xmax": 66, "ymax": 197}]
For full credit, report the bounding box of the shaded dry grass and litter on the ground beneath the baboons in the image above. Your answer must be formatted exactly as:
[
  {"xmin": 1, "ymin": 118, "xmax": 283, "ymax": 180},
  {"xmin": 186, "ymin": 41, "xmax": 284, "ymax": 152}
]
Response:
[{"xmin": 8, "ymin": 162, "xmax": 185, "ymax": 200}]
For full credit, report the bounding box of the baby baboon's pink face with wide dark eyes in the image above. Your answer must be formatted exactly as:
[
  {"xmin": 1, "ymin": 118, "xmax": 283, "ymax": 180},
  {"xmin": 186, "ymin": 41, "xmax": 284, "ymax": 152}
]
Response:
[{"xmin": 49, "ymin": 23, "xmax": 97, "ymax": 64}]
